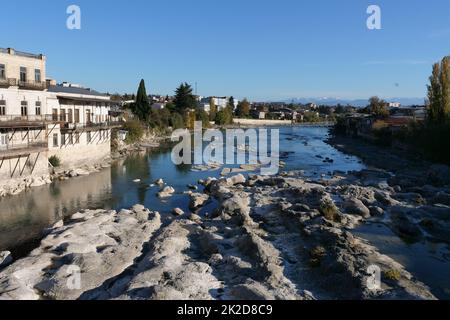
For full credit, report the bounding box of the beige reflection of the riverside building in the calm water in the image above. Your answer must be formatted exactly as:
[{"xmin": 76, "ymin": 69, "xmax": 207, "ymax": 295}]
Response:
[{"xmin": 0, "ymin": 170, "xmax": 112, "ymax": 251}]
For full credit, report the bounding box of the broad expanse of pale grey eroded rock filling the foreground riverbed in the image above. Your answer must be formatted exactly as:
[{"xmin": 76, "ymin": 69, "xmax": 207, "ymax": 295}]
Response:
[{"xmin": 0, "ymin": 165, "xmax": 450, "ymax": 300}]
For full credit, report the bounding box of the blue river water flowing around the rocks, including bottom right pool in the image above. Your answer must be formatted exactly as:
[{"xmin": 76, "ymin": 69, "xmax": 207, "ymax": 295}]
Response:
[{"xmin": 0, "ymin": 127, "xmax": 450, "ymax": 298}]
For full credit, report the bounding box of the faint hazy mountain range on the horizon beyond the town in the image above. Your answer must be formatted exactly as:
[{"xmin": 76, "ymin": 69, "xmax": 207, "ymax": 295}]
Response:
[{"xmin": 282, "ymin": 98, "xmax": 425, "ymax": 107}]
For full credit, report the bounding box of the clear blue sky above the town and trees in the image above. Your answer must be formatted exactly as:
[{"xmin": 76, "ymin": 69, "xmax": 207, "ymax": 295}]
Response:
[{"xmin": 0, "ymin": 0, "xmax": 450, "ymax": 100}]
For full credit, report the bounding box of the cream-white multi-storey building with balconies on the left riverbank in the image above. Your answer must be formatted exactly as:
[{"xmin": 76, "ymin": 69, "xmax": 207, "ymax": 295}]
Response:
[{"xmin": 0, "ymin": 49, "xmax": 118, "ymax": 181}]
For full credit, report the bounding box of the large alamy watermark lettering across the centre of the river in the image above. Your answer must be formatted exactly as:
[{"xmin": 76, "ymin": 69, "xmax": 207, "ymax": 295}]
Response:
[{"xmin": 172, "ymin": 122, "xmax": 280, "ymax": 175}]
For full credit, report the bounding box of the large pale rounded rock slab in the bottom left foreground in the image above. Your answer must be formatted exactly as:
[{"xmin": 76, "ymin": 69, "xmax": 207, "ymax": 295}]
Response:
[{"xmin": 0, "ymin": 206, "xmax": 161, "ymax": 300}]
